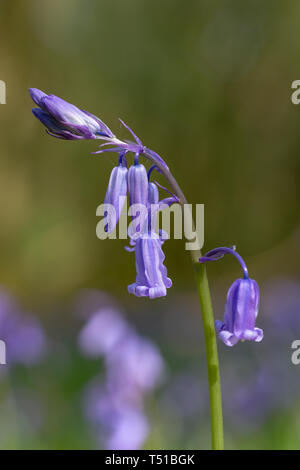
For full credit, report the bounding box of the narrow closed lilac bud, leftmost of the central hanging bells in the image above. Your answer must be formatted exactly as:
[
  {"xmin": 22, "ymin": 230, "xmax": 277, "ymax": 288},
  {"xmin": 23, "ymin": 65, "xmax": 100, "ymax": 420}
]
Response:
[{"xmin": 104, "ymin": 153, "xmax": 128, "ymax": 233}]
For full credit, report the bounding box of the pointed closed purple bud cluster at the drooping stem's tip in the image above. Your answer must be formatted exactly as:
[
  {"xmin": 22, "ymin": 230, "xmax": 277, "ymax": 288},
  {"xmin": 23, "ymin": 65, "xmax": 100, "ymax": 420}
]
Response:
[{"xmin": 29, "ymin": 88, "xmax": 114, "ymax": 140}]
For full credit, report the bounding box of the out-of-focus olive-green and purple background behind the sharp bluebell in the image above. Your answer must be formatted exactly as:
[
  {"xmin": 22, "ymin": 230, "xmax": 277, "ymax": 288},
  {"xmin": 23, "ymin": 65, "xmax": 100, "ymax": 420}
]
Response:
[{"xmin": 0, "ymin": 0, "xmax": 300, "ymax": 449}]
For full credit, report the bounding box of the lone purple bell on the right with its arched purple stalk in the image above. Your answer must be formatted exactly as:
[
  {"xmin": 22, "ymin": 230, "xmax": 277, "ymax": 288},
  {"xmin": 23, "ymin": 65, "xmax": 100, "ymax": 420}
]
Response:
[{"xmin": 199, "ymin": 247, "xmax": 263, "ymax": 346}]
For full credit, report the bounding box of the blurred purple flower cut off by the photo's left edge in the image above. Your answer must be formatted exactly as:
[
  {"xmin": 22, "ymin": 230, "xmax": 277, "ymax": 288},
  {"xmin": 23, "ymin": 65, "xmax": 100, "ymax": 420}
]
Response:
[{"xmin": 0, "ymin": 291, "xmax": 46, "ymax": 365}]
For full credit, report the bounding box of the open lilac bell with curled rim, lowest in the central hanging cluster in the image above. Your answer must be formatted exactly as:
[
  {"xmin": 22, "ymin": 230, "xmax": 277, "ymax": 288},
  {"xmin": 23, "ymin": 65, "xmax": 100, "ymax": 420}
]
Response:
[{"xmin": 128, "ymin": 232, "xmax": 172, "ymax": 299}]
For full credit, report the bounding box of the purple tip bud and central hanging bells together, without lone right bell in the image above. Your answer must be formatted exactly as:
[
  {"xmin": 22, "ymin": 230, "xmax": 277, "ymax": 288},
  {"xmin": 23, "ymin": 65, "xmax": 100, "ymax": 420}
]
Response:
[{"xmin": 29, "ymin": 88, "xmax": 182, "ymax": 298}]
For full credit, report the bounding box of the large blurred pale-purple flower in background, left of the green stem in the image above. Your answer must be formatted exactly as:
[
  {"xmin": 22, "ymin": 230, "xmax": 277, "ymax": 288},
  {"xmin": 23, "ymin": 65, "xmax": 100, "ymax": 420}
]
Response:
[{"xmin": 78, "ymin": 296, "xmax": 165, "ymax": 450}]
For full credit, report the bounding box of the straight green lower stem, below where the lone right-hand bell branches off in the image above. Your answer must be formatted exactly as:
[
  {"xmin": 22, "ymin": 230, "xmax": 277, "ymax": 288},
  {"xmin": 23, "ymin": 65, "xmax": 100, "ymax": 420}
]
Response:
[{"xmin": 194, "ymin": 263, "xmax": 224, "ymax": 450}]
